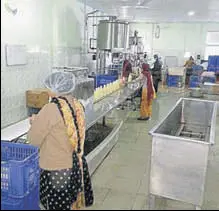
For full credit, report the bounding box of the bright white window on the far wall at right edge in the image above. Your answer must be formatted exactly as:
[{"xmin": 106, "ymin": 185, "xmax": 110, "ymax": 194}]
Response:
[{"xmin": 205, "ymin": 32, "xmax": 219, "ymax": 60}]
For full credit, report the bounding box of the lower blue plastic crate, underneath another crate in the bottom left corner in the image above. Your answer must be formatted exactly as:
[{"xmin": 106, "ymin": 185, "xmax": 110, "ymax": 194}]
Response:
[{"xmin": 1, "ymin": 186, "xmax": 40, "ymax": 210}]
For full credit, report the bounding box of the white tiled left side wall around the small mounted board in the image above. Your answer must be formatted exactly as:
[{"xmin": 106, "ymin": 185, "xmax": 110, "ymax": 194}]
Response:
[{"xmin": 1, "ymin": 0, "xmax": 94, "ymax": 128}]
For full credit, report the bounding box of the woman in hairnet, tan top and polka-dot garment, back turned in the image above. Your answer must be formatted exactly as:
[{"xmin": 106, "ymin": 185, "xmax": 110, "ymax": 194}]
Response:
[{"xmin": 28, "ymin": 72, "xmax": 93, "ymax": 210}]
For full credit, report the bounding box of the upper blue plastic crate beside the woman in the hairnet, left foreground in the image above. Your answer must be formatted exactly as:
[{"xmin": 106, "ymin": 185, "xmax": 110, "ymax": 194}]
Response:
[{"xmin": 1, "ymin": 141, "xmax": 40, "ymax": 198}]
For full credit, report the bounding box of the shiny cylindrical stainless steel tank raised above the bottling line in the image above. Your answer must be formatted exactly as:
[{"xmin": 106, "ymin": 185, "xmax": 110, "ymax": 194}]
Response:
[{"xmin": 97, "ymin": 20, "xmax": 129, "ymax": 50}]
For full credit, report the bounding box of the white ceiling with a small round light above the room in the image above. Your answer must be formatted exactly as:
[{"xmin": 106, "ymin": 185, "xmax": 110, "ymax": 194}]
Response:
[{"xmin": 81, "ymin": 0, "xmax": 219, "ymax": 22}]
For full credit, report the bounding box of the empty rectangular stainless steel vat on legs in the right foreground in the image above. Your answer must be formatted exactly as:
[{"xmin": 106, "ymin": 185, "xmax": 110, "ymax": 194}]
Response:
[{"xmin": 149, "ymin": 98, "xmax": 217, "ymax": 209}]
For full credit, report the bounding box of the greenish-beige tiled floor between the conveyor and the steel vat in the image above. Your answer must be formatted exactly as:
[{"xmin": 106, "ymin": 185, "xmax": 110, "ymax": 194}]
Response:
[{"xmin": 86, "ymin": 90, "xmax": 219, "ymax": 210}]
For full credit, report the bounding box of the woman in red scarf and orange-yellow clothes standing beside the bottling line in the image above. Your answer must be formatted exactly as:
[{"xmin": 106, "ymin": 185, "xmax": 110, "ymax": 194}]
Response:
[{"xmin": 138, "ymin": 64, "xmax": 156, "ymax": 120}]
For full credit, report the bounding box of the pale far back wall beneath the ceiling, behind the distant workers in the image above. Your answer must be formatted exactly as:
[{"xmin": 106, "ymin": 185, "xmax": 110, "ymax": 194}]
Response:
[{"xmin": 131, "ymin": 23, "xmax": 219, "ymax": 65}]
